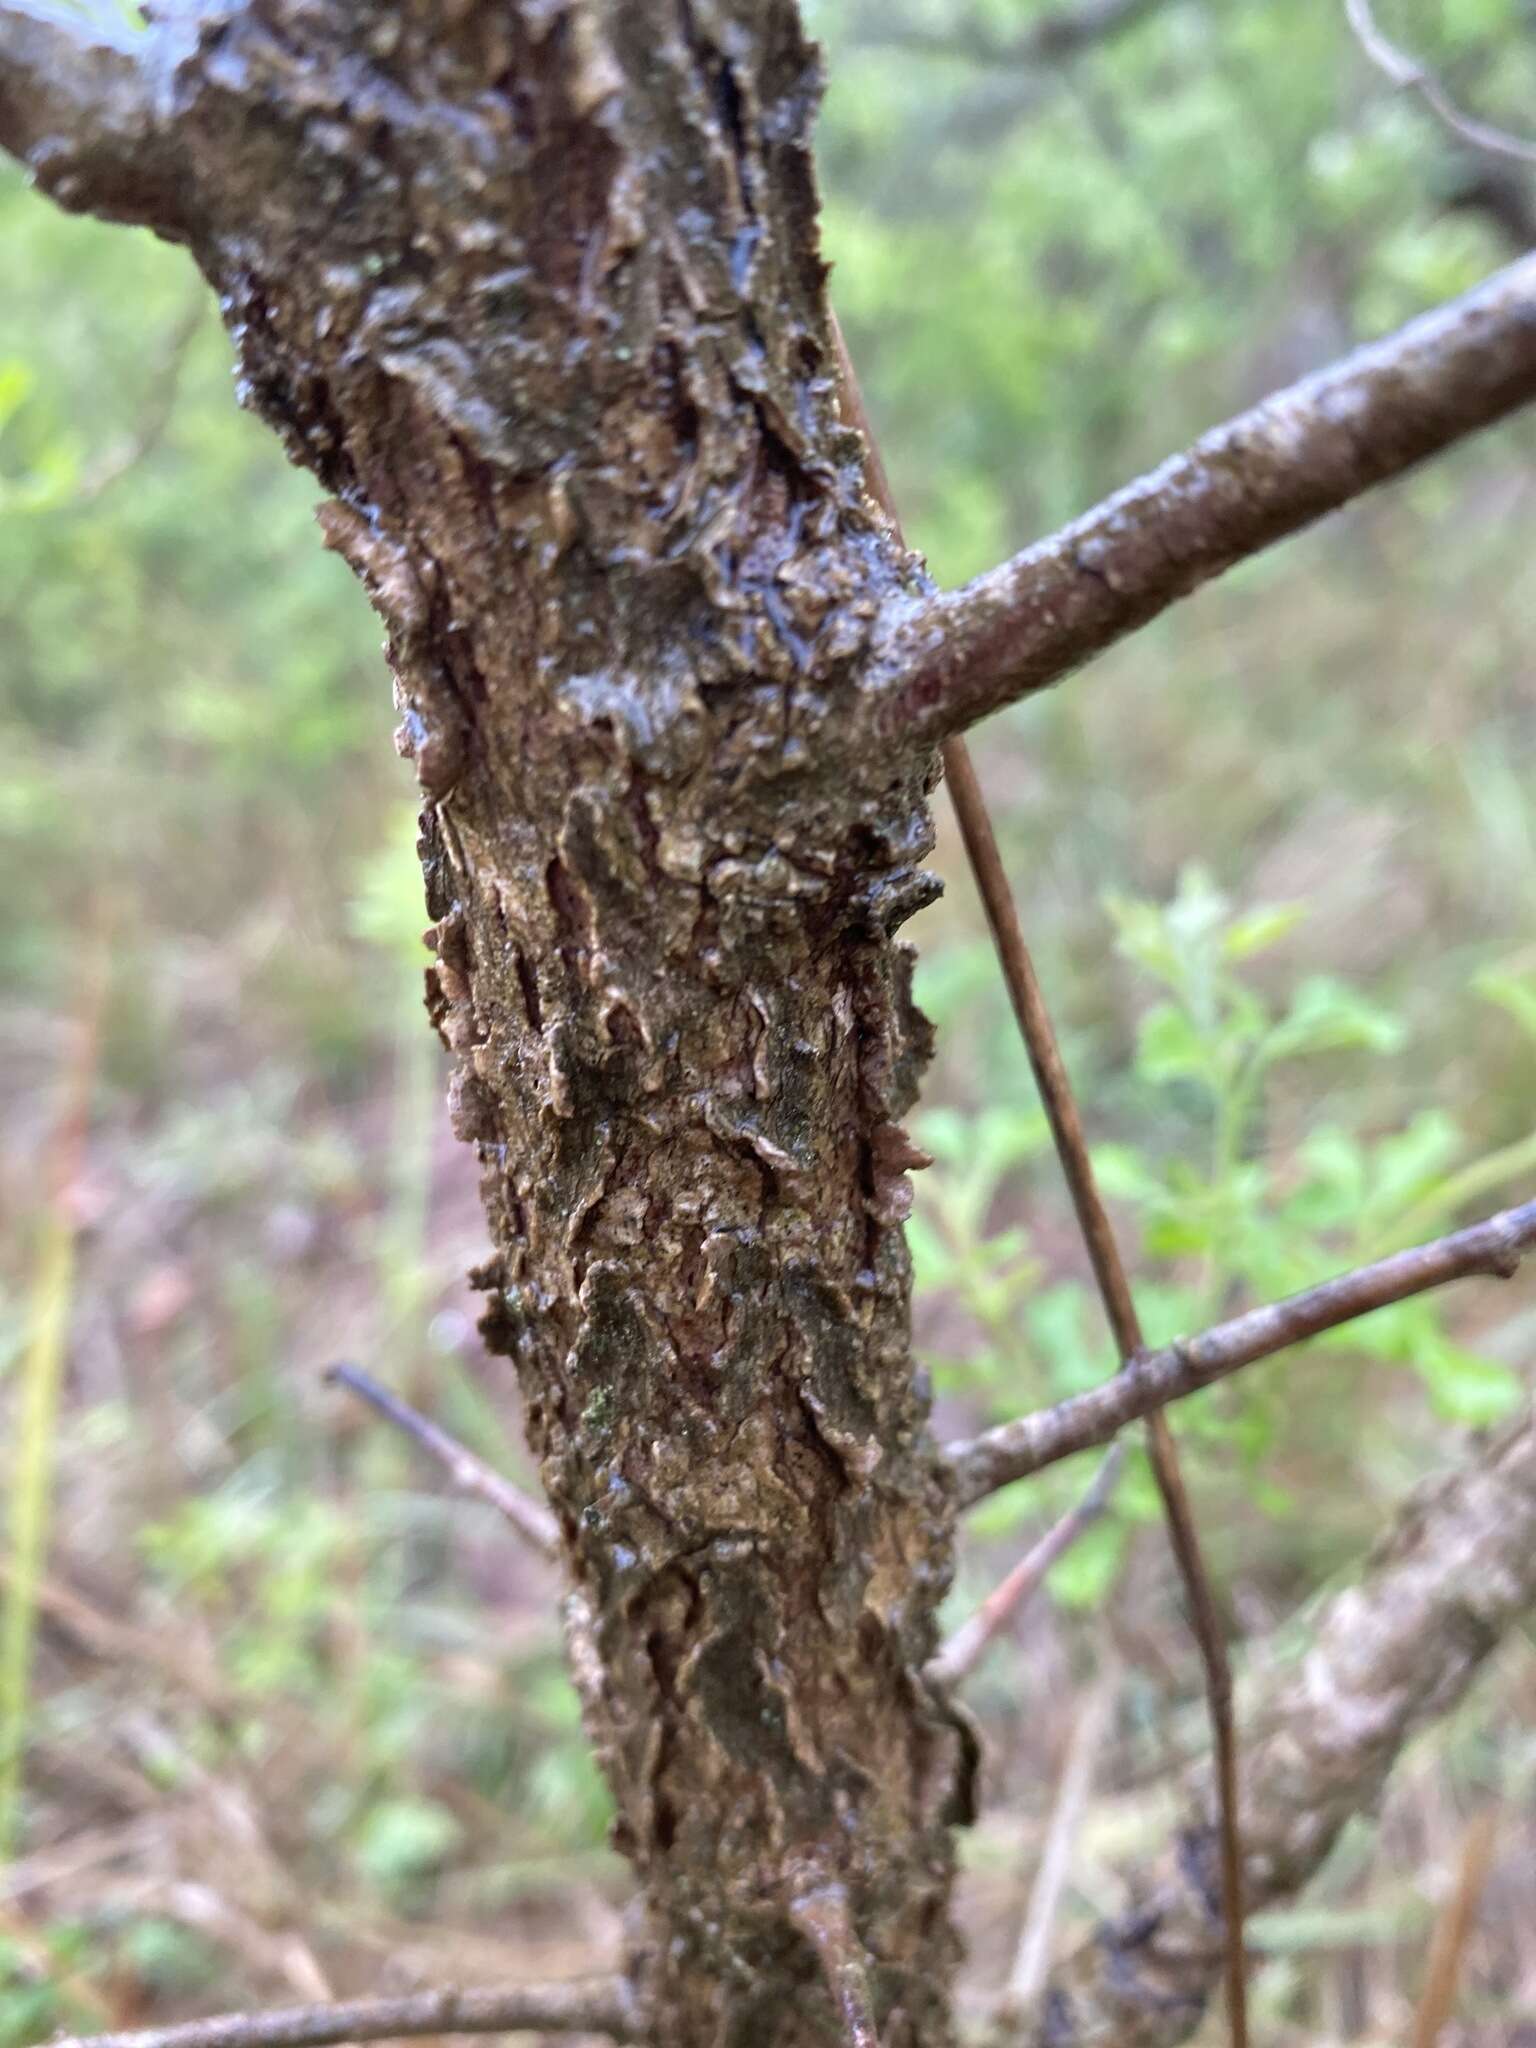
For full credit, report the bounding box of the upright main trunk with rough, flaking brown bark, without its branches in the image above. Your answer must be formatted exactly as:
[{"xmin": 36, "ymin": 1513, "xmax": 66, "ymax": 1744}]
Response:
[{"xmin": 141, "ymin": 0, "xmax": 967, "ymax": 2048}]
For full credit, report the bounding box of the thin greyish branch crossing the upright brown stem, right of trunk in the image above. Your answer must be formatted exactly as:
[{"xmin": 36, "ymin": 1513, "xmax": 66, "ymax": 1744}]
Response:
[{"xmin": 948, "ymin": 1202, "xmax": 1536, "ymax": 1507}]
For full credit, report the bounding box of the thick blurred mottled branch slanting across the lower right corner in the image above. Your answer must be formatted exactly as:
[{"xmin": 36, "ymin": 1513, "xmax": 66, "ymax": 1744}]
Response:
[{"xmin": 991, "ymin": 1409, "xmax": 1536, "ymax": 2048}]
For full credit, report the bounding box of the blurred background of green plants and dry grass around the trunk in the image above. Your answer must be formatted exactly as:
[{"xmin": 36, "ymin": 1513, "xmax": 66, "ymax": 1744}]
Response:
[{"xmin": 0, "ymin": 0, "xmax": 1536, "ymax": 2048}]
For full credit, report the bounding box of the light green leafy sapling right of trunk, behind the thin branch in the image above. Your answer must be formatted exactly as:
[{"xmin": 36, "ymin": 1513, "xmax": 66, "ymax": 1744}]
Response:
[{"xmin": 911, "ymin": 866, "xmax": 1528, "ymax": 1606}]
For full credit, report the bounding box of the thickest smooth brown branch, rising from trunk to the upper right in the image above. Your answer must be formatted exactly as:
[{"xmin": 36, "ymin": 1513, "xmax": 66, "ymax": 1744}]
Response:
[{"xmin": 870, "ymin": 256, "xmax": 1536, "ymax": 745}]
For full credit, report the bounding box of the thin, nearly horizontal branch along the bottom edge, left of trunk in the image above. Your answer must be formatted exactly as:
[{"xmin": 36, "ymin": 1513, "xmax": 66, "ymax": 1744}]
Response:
[{"xmin": 53, "ymin": 1976, "xmax": 641, "ymax": 2048}]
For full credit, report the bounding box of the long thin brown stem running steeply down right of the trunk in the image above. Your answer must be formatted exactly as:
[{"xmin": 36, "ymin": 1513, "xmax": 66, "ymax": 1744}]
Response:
[{"xmin": 834, "ymin": 319, "xmax": 1247, "ymax": 2048}]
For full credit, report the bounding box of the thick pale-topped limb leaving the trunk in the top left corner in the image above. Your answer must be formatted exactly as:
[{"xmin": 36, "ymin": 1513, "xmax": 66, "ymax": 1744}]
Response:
[{"xmin": 0, "ymin": 0, "xmax": 190, "ymax": 240}]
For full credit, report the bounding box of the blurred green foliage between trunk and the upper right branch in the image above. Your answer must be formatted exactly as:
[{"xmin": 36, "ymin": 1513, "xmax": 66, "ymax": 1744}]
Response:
[{"xmin": 809, "ymin": 0, "xmax": 1536, "ymax": 582}]
